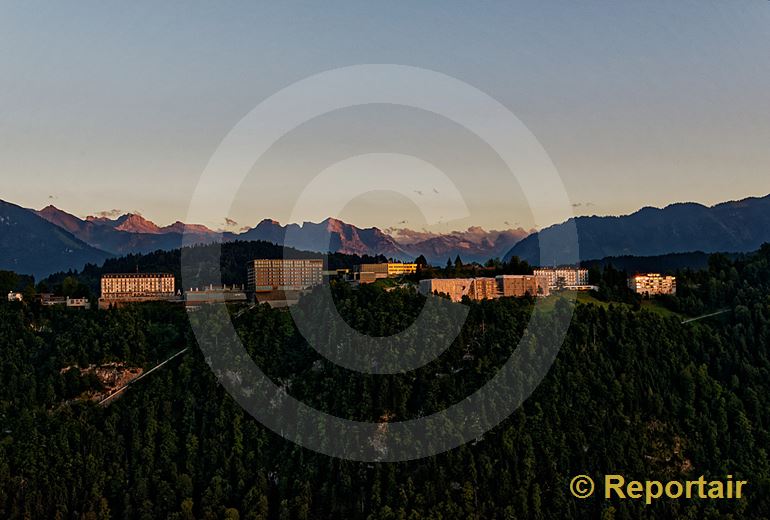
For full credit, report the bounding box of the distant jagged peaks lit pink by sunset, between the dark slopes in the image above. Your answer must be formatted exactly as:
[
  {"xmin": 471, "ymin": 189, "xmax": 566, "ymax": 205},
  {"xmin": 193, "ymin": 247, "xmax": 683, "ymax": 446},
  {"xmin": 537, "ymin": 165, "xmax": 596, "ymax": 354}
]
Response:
[{"xmin": 25, "ymin": 206, "xmax": 528, "ymax": 276}]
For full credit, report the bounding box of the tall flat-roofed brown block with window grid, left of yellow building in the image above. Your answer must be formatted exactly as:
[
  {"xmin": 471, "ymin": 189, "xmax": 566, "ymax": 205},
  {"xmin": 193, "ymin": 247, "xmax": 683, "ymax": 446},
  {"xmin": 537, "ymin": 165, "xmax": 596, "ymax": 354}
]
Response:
[{"xmin": 247, "ymin": 258, "xmax": 323, "ymax": 293}]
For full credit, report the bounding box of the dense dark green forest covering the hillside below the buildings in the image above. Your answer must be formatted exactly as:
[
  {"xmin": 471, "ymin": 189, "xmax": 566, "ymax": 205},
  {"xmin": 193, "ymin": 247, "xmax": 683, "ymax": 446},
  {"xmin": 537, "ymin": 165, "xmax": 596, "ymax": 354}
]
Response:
[{"xmin": 0, "ymin": 246, "xmax": 770, "ymax": 520}]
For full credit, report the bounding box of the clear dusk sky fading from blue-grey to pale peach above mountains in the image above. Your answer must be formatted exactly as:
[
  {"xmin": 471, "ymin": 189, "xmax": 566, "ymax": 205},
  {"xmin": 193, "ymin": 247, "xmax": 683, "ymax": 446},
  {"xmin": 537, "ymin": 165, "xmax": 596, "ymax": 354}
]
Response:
[{"xmin": 0, "ymin": 0, "xmax": 770, "ymax": 231}]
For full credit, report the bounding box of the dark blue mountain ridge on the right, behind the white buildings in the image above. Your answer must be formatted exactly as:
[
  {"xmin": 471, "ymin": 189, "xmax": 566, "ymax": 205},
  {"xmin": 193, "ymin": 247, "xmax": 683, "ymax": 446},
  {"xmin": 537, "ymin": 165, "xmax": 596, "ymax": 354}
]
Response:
[{"xmin": 506, "ymin": 195, "xmax": 770, "ymax": 265}]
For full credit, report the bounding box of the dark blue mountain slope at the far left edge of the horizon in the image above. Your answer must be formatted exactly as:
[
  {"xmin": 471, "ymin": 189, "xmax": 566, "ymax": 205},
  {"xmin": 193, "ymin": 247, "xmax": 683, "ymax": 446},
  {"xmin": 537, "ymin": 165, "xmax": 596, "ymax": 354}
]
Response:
[{"xmin": 0, "ymin": 200, "xmax": 110, "ymax": 279}]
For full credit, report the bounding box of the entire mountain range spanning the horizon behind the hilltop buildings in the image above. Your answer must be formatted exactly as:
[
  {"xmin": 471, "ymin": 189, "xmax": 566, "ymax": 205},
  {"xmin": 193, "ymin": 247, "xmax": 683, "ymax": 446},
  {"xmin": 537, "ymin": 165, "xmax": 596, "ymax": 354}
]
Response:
[{"xmin": 0, "ymin": 195, "xmax": 770, "ymax": 277}]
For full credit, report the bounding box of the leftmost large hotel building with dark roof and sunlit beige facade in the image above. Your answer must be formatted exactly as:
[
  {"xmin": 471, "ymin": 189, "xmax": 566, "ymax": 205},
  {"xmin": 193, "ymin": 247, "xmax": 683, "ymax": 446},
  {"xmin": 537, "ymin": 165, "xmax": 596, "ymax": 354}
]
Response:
[{"xmin": 99, "ymin": 273, "xmax": 176, "ymax": 309}]
